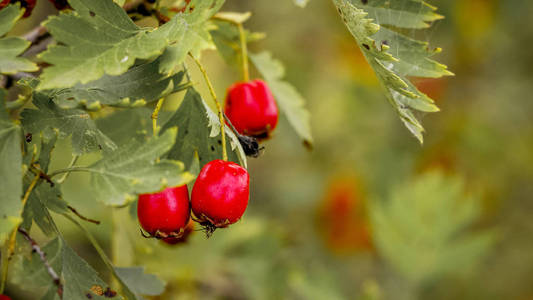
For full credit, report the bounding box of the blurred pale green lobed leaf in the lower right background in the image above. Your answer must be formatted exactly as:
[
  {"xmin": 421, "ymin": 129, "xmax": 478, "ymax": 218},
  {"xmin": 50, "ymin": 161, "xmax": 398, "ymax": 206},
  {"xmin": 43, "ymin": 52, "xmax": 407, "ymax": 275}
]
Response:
[{"xmin": 370, "ymin": 173, "xmax": 494, "ymax": 283}]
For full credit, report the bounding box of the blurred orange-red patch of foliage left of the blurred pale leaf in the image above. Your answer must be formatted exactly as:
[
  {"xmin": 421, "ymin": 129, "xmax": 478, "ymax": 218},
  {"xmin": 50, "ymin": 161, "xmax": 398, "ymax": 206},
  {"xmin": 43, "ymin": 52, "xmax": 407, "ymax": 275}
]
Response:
[{"xmin": 317, "ymin": 176, "xmax": 373, "ymax": 254}]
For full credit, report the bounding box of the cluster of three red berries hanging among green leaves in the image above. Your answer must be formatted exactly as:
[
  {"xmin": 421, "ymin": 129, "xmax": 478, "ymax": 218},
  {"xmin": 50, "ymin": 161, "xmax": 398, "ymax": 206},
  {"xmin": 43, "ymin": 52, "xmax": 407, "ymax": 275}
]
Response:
[{"xmin": 137, "ymin": 80, "xmax": 278, "ymax": 244}]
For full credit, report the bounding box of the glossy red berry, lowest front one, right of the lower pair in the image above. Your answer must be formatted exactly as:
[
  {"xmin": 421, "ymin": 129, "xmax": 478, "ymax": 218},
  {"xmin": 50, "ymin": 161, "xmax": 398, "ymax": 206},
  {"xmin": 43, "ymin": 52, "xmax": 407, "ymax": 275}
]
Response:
[{"xmin": 191, "ymin": 159, "xmax": 250, "ymax": 233}]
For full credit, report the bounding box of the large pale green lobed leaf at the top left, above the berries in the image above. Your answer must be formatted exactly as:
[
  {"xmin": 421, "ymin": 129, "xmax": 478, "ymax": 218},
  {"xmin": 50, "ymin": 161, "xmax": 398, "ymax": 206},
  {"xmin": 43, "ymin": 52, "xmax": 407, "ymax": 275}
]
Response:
[{"xmin": 38, "ymin": 0, "xmax": 223, "ymax": 90}]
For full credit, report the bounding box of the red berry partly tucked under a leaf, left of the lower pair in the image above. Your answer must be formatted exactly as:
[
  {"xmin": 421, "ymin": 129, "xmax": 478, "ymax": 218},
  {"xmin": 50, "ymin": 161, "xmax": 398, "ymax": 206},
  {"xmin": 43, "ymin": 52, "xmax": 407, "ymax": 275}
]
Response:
[{"xmin": 137, "ymin": 185, "xmax": 190, "ymax": 238}]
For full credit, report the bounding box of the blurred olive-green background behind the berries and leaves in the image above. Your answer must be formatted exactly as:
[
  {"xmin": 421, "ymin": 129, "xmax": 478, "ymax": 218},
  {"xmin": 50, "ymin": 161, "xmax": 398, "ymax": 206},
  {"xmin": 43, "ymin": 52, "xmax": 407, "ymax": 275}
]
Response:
[{"xmin": 8, "ymin": 0, "xmax": 533, "ymax": 300}]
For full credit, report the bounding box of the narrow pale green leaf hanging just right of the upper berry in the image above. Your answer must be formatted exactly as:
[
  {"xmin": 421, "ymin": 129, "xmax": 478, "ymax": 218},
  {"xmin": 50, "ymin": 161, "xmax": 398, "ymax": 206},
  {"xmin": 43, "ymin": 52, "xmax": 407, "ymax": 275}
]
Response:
[{"xmin": 250, "ymin": 52, "xmax": 313, "ymax": 145}]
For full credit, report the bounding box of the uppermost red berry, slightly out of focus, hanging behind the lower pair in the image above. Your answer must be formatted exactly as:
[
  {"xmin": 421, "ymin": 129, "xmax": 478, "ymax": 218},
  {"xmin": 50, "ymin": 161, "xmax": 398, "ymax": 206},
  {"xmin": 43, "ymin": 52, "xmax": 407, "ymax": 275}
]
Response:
[{"xmin": 224, "ymin": 79, "xmax": 278, "ymax": 137}]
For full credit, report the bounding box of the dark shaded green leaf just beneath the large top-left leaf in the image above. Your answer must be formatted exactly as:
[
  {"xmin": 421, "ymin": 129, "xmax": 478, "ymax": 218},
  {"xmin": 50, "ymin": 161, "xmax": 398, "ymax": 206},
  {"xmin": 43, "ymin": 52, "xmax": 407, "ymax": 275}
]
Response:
[{"xmin": 47, "ymin": 59, "xmax": 187, "ymax": 110}]
